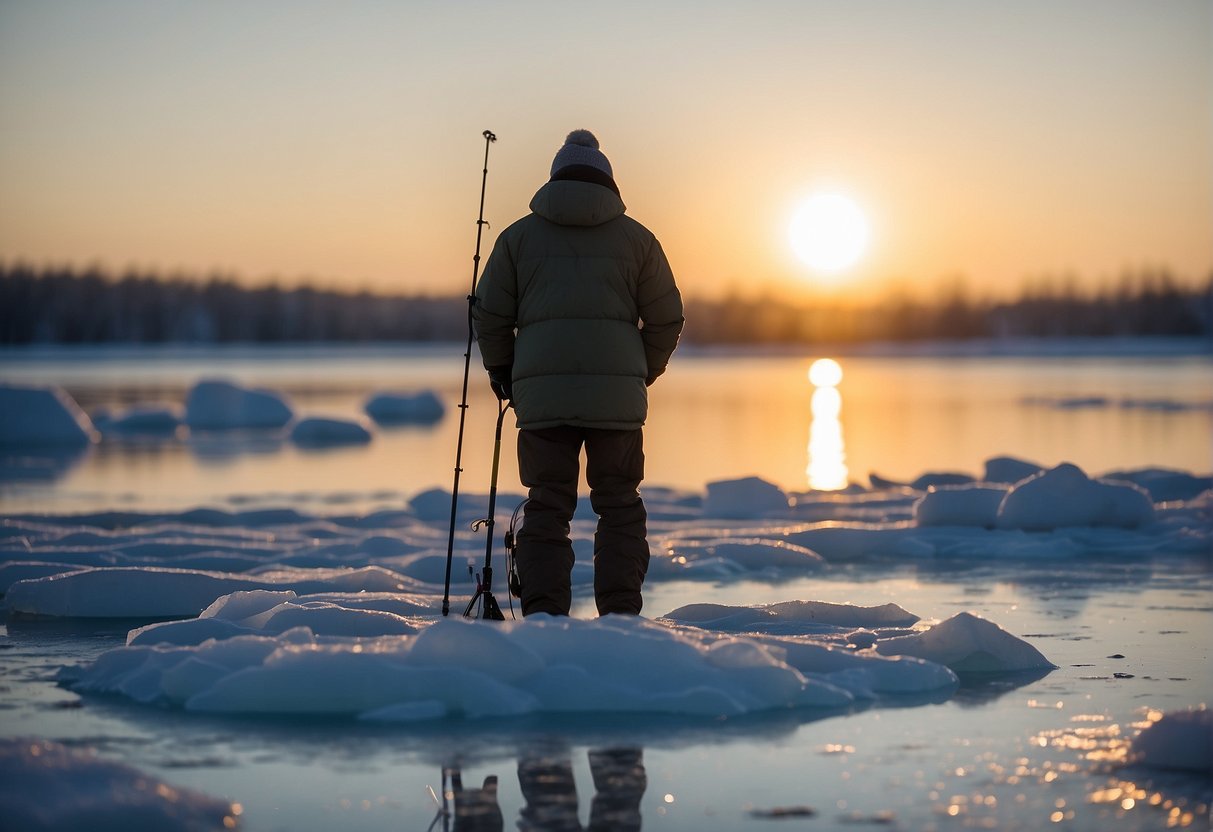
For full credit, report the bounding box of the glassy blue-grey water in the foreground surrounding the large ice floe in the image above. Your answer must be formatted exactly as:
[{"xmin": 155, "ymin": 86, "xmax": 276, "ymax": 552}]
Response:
[{"xmin": 0, "ymin": 559, "xmax": 1213, "ymax": 830}]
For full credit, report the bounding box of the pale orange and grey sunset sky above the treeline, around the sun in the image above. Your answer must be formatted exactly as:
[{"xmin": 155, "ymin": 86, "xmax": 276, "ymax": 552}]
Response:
[{"xmin": 0, "ymin": 0, "xmax": 1213, "ymax": 298}]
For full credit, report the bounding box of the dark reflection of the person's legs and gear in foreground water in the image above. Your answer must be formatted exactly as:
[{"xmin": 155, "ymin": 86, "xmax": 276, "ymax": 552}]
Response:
[{"xmin": 435, "ymin": 748, "xmax": 648, "ymax": 832}]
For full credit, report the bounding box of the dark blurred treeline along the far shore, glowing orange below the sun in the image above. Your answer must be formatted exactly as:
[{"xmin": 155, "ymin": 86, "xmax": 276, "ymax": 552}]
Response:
[{"xmin": 0, "ymin": 264, "xmax": 1213, "ymax": 344}]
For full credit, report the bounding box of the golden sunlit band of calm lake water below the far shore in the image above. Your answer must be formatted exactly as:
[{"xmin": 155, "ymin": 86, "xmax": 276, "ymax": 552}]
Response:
[{"xmin": 0, "ymin": 344, "xmax": 1213, "ymax": 511}]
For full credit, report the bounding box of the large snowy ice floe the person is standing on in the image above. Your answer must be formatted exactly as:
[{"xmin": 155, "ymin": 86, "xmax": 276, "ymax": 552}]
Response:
[{"xmin": 47, "ymin": 591, "xmax": 1052, "ymax": 720}]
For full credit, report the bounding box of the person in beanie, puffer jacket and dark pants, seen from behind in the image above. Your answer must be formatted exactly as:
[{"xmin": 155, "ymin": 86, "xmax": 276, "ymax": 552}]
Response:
[{"xmin": 472, "ymin": 130, "xmax": 683, "ymax": 616}]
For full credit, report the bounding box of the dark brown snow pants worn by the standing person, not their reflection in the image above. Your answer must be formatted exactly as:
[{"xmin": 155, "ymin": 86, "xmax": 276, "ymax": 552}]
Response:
[{"xmin": 516, "ymin": 424, "xmax": 649, "ymax": 616}]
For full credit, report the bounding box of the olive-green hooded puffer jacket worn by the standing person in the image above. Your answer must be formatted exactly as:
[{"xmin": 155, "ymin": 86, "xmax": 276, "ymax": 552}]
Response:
[{"xmin": 473, "ymin": 181, "xmax": 683, "ymax": 429}]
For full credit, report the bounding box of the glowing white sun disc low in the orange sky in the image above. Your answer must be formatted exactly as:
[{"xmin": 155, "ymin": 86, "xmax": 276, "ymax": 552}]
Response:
[{"xmin": 787, "ymin": 193, "xmax": 871, "ymax": 274}]
